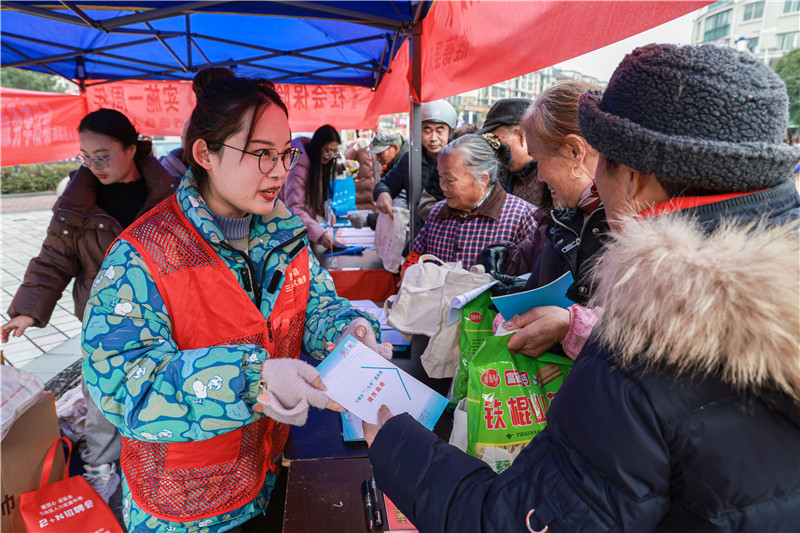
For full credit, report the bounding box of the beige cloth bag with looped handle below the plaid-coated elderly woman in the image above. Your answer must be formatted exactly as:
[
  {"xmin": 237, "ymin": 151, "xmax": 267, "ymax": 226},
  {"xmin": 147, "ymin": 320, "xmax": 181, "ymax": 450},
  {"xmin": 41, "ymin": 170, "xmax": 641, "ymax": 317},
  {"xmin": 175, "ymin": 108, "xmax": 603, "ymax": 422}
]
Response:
[{"xmin": 383, "ymin": 254, "xmax": 463, "ymax": 337}]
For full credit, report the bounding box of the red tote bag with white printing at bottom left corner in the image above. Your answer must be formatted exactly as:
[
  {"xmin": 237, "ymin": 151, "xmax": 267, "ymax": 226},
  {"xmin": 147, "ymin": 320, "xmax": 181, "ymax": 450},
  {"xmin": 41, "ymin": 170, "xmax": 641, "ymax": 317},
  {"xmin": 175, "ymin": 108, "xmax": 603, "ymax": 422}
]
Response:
[{"xmin": 19, "ymin": 437, "xmax": 124, "ymax": 533}]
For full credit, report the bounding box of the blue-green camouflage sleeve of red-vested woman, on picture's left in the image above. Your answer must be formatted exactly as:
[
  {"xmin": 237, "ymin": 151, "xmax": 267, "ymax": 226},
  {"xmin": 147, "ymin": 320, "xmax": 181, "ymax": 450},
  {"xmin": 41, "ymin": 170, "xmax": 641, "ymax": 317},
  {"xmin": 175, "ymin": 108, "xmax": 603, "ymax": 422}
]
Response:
[{"xmin": 81, "ymin": 240, "xmax": 267, "ymax": 442}]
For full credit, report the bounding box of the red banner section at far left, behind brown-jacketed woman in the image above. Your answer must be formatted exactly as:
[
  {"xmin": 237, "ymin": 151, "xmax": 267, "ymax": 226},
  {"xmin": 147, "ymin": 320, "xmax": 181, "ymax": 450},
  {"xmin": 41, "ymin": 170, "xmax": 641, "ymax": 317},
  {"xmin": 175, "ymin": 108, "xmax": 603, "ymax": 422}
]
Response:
[{"xmin": 0, "ymin": 87, "xmax": 86, "ymax": 166}]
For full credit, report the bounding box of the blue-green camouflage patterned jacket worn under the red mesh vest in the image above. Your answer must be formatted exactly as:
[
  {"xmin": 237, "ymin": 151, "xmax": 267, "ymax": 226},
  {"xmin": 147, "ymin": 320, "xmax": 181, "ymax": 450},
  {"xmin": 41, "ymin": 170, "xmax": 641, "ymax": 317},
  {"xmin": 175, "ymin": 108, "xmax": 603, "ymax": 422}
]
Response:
[{"xmin": 82, "ymin": 172, "xmax": 380, "ymax": 531}]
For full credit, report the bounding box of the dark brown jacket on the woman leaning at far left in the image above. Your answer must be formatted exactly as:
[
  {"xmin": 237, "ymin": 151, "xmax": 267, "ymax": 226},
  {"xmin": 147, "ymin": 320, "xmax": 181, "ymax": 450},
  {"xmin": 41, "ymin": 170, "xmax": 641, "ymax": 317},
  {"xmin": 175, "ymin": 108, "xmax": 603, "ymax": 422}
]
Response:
[{"xmin": 8, "ymin": 157, "xmax": 178, "ymax": 327}]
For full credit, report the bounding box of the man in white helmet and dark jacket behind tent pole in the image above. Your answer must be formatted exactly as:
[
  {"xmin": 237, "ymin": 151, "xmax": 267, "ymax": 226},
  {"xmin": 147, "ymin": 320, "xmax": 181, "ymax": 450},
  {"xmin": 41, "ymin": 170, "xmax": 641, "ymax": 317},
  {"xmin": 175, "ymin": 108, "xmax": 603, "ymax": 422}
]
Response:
[{"xmin": 373, "ymin": 100, "xmax": 458, "ymax": 220}]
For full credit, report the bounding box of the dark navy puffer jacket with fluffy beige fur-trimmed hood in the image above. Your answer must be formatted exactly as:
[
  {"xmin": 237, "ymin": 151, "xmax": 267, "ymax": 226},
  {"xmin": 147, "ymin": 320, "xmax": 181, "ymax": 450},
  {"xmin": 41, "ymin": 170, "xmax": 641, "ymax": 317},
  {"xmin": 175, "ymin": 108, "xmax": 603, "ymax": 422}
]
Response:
[{"xmin": 369, "ymin": 182, "xmax": 800, "ymax": 533}]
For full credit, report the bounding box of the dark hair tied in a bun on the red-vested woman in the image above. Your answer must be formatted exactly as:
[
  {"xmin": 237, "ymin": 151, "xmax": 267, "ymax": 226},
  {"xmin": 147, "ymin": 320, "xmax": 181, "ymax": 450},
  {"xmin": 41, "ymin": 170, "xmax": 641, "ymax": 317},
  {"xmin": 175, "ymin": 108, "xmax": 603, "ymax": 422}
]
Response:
[{"xmin": 183, "ymin": 77, "xmax": 289, "ymax": 185}]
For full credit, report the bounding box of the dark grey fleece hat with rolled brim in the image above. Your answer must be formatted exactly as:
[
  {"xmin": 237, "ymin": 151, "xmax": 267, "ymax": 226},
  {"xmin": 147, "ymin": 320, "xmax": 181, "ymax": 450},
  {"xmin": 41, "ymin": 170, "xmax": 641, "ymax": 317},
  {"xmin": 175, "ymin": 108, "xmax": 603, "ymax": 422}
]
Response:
[{"xmin": 578, "ymin": 44, "xmax": 800, "ymax": 195}]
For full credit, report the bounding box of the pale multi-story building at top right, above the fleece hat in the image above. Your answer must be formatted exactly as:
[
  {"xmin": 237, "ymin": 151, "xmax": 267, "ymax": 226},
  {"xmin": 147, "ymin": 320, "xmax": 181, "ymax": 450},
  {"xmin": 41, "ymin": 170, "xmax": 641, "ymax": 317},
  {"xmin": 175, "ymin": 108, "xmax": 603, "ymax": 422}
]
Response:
[{"xmin": 692, "ymin": 0, "xmax": 800, "ymax": 66}]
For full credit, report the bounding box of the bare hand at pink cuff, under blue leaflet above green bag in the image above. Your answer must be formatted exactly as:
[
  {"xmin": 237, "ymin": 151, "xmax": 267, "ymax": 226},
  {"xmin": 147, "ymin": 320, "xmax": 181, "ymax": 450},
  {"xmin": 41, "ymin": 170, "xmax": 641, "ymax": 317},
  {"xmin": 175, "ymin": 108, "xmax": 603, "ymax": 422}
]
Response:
[{"xmin": 503, "ymin": 306, "xmax": 569, "ymax": 357}]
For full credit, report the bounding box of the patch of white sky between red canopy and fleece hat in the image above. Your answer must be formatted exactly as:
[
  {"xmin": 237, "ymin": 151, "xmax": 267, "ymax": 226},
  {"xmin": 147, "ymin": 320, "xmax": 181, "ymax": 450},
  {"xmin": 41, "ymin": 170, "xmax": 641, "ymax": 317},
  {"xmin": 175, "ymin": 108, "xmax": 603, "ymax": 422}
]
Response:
[{"xmin": 555, "ymin": 11, "xmax": 697, "ymax": 81}]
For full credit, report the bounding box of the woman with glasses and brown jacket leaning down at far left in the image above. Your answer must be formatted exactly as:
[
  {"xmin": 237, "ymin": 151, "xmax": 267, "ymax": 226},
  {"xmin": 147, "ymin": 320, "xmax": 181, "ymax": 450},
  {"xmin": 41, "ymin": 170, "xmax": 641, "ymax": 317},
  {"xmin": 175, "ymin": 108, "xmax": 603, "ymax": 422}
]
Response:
[{"xmin": 0, "ymin": 109, "xmax": 176, "ymax": 501}]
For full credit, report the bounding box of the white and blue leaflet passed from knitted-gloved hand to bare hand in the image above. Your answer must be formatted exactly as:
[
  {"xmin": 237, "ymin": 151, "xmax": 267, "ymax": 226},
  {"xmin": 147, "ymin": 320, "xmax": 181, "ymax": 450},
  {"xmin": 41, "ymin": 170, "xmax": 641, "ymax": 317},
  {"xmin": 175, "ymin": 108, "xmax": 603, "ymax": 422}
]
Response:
[{"xmin": 317, "ymin": 335, "xmax": 447, "ymax": 430}]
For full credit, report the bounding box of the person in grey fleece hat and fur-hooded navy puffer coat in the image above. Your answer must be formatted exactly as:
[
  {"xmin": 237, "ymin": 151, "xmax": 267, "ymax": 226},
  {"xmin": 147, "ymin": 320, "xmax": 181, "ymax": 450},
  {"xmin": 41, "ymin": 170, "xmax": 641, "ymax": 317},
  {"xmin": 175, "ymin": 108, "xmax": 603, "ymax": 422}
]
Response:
[{"xmin": 365, "ymin": 45, "xmax": 800, "ymax": 533}]
